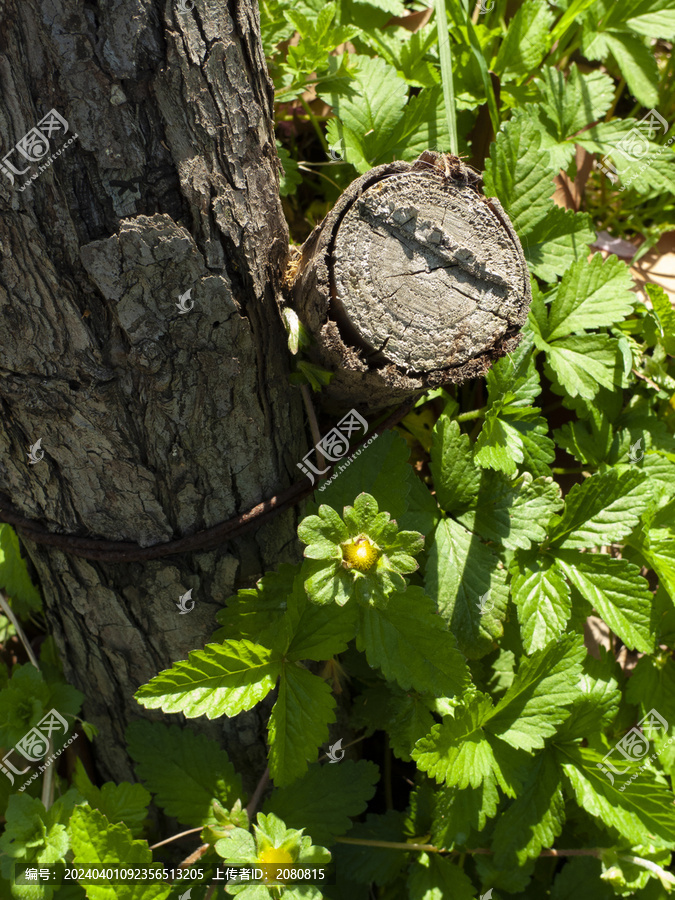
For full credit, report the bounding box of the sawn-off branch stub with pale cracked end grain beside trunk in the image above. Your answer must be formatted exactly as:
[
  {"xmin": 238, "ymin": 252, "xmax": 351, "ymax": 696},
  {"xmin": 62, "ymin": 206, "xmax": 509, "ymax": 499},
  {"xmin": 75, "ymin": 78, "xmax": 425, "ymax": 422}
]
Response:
[{"xmin": 291, "ymin": 151, "xmax": 532, "ymax": 410}]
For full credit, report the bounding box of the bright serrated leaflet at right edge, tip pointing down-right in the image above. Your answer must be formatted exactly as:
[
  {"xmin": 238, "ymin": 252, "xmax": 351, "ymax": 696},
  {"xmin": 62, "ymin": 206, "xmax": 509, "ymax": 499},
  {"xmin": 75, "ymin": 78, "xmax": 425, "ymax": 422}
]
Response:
[{"xmin": 556, "ymin": 550, "xmax": 654, "ymax": 653}]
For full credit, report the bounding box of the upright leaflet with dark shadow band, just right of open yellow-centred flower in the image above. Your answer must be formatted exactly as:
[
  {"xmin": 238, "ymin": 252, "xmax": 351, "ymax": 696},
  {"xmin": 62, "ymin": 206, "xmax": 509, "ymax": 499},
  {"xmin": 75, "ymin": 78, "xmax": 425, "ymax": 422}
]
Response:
[{"xmin": 425, "ymin": 519, "xmax": 508, "ymax": 659}]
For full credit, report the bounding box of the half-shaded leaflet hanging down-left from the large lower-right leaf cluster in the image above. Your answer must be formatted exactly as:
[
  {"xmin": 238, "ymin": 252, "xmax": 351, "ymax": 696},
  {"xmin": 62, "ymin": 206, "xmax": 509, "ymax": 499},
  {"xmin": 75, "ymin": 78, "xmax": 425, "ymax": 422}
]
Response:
[{"xmin": 492, "ymin": 750, "xmax": 565, "ymax": 868}]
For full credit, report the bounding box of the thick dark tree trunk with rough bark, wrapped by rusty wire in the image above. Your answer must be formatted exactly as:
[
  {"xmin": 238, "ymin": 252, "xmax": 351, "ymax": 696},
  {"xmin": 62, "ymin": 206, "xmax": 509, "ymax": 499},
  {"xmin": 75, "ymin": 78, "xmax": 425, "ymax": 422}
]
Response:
[{"xmin": 0, "ymin": 0, "xmax": 306, "ymax": 782}]
